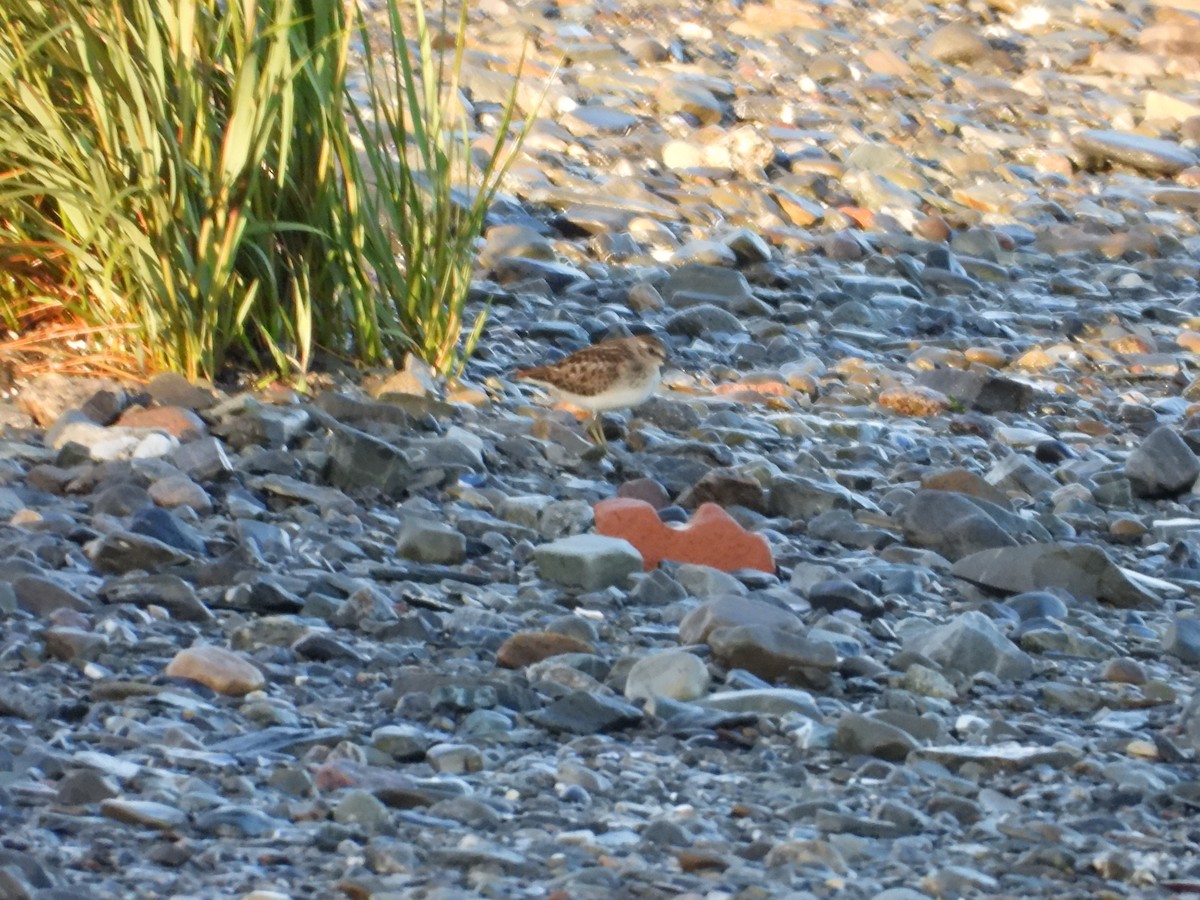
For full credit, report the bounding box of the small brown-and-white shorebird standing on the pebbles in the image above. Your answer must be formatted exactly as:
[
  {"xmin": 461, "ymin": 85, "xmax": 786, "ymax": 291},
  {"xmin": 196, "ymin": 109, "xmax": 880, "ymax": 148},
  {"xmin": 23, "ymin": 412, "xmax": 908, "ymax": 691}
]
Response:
[{"xmin": 516, "ymin": 335, "xmax": 667, "ymax": 446}]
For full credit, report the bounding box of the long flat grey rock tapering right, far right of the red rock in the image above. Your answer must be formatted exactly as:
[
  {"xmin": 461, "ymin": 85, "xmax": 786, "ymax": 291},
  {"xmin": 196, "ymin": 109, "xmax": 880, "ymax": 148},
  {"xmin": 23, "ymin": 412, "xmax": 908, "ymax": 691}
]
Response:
[{"xmin": 950, "ymin": 544, "xmax": 1158, "ymax": 607}]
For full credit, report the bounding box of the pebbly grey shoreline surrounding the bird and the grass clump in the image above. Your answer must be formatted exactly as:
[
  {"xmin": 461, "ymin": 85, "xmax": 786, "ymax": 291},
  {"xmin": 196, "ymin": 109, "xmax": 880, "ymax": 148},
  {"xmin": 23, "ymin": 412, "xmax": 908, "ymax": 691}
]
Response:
[{"xmin": 7, "ymin": 0, "xmax": 1200, "ymax": 900}]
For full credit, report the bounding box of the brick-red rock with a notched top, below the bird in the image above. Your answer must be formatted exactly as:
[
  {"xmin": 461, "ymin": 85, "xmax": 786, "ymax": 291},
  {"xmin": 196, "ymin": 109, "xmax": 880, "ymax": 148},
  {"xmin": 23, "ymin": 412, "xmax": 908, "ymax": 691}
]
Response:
[{"xmin": 593, "ymin": 497, "xmax": 775, "ymax": 572}]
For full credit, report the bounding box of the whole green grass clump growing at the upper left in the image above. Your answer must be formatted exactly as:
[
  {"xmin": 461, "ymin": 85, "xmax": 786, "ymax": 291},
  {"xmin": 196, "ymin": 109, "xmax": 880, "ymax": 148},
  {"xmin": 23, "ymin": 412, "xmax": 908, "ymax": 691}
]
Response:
[{"xmin": 0, "ymin": 0, "xmax": 540, "ymax": 377}]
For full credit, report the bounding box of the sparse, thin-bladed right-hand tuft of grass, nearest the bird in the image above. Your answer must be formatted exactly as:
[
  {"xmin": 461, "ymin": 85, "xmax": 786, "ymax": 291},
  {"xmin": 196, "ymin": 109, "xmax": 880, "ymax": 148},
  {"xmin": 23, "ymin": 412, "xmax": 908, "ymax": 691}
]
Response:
[{"xmin": 352, "ymin": 0, "xmax": 540, "ymax": 372}]
